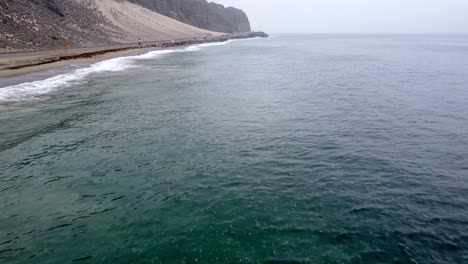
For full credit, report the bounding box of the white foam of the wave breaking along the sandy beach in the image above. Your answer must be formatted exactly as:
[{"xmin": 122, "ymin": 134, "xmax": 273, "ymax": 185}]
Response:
[{"xmin": 0, "ymin": 40, "xmax": 231, "ymax": 103}]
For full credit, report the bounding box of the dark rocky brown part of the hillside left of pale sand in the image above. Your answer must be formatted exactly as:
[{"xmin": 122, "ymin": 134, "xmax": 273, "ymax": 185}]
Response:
[{"xmin": 0, "ymin": 0, "xmax": 118, "ymax": 49}]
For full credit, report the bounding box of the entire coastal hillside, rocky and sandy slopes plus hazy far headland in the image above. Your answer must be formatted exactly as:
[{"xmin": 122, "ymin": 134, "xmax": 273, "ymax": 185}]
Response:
[{"xmin": 0, "ymin": 0, "xmax": 250, "ymax": 52}]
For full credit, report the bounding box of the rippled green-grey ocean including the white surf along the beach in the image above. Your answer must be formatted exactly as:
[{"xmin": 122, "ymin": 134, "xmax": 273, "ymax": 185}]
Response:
[{"xmin": 0, "ymin": 34, "xmax": 468, "ymax": 264}]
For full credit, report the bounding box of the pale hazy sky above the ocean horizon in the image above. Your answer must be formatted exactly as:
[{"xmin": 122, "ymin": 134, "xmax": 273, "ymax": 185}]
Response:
[{"xmin": 212, "ymin": 0, "xmax": 468, "ymax": 33}]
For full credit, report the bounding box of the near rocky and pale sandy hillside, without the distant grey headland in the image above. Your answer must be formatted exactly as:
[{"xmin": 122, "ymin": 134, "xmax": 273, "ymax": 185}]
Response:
[{"xmin": 0, "ymin": 0, "xmax": 227, "ymax": 51}]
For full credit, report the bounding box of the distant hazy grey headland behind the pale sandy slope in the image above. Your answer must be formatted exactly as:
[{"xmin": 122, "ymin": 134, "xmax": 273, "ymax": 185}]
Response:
[{"xmin": 128, "ymin": 0, "xmax": 251, "ymax": 33}]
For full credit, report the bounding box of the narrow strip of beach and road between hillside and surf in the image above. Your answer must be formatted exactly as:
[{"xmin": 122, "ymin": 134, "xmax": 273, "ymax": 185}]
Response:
[{"xmin": 0, "ymin": 32, "xmax": 268, "ymax": 79}]
